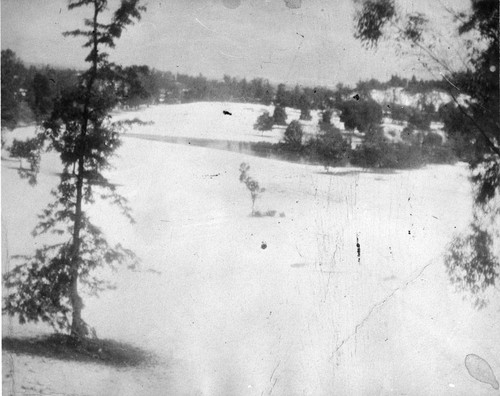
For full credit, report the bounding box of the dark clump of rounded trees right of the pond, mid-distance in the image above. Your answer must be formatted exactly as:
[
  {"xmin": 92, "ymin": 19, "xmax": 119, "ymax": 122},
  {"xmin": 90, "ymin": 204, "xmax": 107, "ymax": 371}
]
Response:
[{"xmin": 254, "ymin": 86, "xmax": 457, "ymax": 169}]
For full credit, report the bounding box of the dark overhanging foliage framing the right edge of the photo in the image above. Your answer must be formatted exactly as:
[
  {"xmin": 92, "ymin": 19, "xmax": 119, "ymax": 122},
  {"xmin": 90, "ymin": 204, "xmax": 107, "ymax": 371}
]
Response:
[{"xmin": 355, "ymin": 0, "xmax": 500, "ymax": 307}]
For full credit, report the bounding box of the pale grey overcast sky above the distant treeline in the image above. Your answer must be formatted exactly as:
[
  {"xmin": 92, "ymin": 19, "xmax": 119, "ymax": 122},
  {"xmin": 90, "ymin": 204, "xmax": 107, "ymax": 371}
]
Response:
[{"xmin": 1, "ymin": 0, "xmax": 470, "ymax": 86}]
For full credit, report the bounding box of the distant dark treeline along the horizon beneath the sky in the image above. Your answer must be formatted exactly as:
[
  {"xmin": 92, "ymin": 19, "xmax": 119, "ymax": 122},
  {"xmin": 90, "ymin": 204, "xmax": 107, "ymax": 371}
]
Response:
[{"xmin": 2, "ymin": 49, "xmax": 444, "ymax": 128}]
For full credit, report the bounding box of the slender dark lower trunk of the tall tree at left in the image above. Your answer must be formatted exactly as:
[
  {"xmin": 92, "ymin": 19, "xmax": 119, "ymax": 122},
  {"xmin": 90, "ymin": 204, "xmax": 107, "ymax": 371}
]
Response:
[{"xmin": 70, "ymin": 156, "xmax": 87, "ymax": 338}]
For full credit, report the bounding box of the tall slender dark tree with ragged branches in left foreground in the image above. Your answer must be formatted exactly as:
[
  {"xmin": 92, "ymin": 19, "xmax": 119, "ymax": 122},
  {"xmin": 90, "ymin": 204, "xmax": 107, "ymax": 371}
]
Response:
[{"xmin": 4, "ymin": 0, "xmax": 144, "ymax": 340}]
